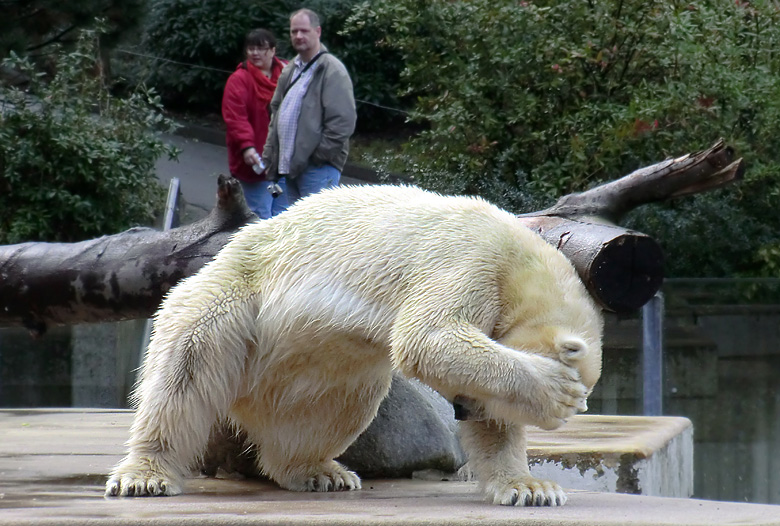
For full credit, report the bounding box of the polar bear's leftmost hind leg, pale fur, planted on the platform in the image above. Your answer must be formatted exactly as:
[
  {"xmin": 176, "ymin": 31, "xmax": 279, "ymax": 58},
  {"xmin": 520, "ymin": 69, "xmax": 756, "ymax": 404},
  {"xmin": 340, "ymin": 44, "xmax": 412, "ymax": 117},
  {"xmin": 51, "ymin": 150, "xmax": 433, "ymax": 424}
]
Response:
[{"xmin": 106, "ymin": 290, "xmax": 253, "ymax": 496}]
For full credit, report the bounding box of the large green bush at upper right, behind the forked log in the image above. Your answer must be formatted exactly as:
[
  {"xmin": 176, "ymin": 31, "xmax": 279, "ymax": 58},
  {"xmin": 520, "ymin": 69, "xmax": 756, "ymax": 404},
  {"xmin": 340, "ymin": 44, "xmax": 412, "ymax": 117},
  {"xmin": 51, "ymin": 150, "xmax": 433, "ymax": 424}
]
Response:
[{"xmin": 350, "ymin": 0, "xmax": 780, "ymax": 275}]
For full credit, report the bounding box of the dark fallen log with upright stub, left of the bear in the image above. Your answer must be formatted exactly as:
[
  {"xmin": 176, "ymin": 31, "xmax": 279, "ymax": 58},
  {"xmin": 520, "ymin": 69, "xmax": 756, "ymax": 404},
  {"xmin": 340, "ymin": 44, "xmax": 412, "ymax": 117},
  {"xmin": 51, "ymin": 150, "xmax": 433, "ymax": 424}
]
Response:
[{"xmin": 0, "ymin": 175, "xmax": 256, "ymax": 334}]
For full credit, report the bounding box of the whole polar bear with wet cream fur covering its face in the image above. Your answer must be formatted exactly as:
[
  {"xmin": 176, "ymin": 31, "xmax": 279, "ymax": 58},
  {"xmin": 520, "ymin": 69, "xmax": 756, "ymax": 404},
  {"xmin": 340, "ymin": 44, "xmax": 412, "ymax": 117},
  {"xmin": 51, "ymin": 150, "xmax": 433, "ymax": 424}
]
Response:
[{"xmin": 106, "ymin": 185, "xmax": 602, "ymax": 506}]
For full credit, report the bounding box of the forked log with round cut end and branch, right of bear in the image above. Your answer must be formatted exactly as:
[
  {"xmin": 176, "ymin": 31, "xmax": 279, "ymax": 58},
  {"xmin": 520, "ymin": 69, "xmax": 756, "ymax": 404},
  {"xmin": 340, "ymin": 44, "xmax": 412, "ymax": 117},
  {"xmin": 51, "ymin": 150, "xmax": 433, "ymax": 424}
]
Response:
[{"xmin": 519, "ymin": 139, "xmax": 745, "ymax": 312}]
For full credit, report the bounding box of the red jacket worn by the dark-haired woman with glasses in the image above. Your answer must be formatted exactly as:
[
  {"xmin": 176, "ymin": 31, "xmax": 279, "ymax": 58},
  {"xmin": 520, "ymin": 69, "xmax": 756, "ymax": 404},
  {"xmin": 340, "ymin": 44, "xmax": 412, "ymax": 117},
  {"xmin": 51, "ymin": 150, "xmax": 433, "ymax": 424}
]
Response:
[{"xmin": 222, "ymin": 57, "xmax": 285, "ymax": 182}]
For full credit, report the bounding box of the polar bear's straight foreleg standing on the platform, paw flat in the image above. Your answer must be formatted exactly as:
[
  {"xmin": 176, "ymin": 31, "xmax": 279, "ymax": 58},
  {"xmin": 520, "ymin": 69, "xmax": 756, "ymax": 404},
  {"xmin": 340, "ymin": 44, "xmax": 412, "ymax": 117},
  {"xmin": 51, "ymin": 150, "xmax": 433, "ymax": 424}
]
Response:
[{"xmin": 460, "ymin": 420, "xmax": 566, "ymax": 506}]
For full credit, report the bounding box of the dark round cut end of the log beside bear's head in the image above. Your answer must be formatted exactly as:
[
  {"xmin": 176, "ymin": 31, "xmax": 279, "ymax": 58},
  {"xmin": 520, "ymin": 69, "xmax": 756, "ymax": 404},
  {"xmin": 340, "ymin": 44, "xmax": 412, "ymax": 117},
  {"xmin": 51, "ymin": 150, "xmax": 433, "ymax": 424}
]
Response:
[{"xmin": 585, "ymin": 233, "xmax": 664, "ymax": 314}]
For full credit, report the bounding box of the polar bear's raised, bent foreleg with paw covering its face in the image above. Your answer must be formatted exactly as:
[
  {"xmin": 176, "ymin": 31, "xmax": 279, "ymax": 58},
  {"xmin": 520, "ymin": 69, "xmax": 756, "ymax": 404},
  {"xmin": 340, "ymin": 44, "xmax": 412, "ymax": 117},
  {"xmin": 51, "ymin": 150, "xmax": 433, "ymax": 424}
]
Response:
[{"xmin": 392, "ymin": 322, "xmax": 588, "ymax": 429}]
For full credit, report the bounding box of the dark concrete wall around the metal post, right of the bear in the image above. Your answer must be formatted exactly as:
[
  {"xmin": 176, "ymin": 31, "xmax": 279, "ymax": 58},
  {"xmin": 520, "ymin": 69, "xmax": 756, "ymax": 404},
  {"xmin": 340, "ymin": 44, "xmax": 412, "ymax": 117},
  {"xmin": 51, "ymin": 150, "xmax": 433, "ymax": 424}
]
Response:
[{"xmin": 589, "ymin": 305, "xmax": 780, "ymax": 504}]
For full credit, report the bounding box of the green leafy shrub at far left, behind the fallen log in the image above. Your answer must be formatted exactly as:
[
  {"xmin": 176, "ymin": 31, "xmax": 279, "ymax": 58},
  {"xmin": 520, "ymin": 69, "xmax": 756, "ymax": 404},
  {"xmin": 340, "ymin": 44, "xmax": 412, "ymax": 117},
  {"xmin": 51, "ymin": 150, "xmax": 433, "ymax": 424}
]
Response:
[{"xmin": 0, "ymin": 23, "xmax": 175, "ymax": 243}]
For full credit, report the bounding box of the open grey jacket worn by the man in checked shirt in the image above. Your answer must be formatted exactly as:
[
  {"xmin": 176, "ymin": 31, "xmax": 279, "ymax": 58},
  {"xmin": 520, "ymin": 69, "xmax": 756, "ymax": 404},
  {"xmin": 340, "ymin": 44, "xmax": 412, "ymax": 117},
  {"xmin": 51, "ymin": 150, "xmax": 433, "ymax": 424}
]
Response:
[{"xmin": 263, "ymin": 46, "xmax": 357, "ymax": 179}]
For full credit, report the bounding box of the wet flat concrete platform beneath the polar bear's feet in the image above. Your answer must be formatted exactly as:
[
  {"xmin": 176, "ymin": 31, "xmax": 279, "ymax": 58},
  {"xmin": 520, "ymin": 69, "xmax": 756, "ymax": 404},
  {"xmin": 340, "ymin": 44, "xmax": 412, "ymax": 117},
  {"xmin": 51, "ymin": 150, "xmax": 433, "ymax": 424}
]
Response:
[{"xmin": 0, "ymin": 409, "xmax": 780, "ymax": 526}]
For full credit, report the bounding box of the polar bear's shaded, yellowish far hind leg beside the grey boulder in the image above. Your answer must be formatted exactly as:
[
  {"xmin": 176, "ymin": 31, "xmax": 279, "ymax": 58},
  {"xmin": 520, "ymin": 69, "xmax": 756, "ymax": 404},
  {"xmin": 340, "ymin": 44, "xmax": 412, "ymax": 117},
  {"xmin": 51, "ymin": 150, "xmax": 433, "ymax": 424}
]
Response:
[{"xmin": 241, "ymin": 343, "xmax": 391, "ymax": 491}]
